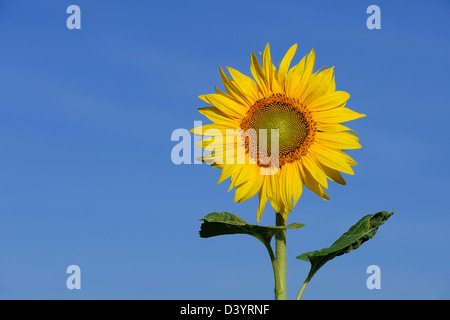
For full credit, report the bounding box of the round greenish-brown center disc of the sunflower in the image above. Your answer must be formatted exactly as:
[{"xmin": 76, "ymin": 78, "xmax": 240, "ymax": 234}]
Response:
[{"xmin": 241, "ymin": 94, "xmax": 316, "ymax": 166}]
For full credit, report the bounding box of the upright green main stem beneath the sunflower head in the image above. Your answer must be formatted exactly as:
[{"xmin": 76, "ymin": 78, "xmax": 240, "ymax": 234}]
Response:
[{"xmin": 275, "ymin": 213, "xmax": 287, "ymax": 300}]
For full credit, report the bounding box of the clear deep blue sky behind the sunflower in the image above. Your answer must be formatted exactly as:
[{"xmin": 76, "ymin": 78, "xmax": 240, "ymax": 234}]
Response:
[{"xmin": 0, "ymin": 0, "xmax": 450, "ymax": 299}]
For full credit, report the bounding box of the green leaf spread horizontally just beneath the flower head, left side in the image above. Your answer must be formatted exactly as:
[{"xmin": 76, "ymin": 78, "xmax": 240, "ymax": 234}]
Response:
[{"xmin": 200, "ymin": 212, "xmax": 305, "ymax": 245}]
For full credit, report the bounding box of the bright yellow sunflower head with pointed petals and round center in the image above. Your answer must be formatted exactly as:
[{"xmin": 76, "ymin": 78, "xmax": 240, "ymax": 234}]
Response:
[{"xmin": 191, "ymin": 44, "xmax": 365, "ymax": 222}]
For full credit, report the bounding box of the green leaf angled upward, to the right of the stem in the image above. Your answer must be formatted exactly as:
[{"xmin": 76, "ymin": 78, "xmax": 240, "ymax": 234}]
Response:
[{"xmin": 297, "ymin": 211, "xmax": 394, "ymax": 280}]
